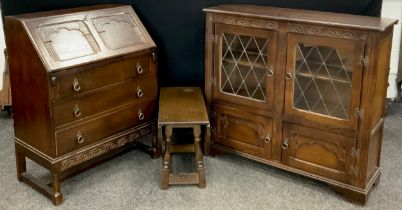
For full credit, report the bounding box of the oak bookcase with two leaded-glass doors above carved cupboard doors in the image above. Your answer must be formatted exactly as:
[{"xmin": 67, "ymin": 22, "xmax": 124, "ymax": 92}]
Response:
[{"xmin": 204, "ymin": 5, "xmax": 396, "ymax": 203}]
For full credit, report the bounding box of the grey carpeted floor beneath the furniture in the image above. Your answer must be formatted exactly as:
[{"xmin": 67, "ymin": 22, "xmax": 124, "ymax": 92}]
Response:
[{"xmin": 0, "ymin": 104, "xmax": 402, "ymax": 210}]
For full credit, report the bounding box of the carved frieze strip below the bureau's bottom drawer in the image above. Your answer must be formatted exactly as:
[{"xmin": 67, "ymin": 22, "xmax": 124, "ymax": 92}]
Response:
[{"xmin": 61, "ymin": 127, "xmax": 152, "ymax": 170}]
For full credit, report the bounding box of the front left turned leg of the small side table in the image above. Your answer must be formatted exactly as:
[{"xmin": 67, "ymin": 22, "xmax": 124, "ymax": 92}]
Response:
[{"xmin": 162, "ymin": 125, "xmax": 172, "ymax": 190}]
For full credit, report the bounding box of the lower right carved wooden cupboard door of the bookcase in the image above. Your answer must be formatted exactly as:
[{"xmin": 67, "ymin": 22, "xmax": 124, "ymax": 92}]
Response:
[{"xmin": 282, "ymin": 124, "xmax": 356, "ymax": 184}]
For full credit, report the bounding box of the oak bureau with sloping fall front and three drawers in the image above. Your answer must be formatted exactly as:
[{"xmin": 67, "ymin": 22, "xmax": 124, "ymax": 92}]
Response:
[{"xmin": 5, "ymin": 5, "xmax": 159, "ymax": 205}]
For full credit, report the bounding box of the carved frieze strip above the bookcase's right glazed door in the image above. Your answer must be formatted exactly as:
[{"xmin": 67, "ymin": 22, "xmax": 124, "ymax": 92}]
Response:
[{"xmin": 288, "ymin": 23, "xmax": 368, "ymax": 41}]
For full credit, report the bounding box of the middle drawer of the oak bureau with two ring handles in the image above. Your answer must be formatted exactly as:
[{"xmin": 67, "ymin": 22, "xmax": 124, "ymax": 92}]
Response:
[{"xmin": 53, "ymin": 76, "xmax": 157, "ymax": 127}]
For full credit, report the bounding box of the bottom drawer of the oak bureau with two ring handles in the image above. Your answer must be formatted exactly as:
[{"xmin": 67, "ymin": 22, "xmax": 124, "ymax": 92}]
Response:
[{"xmin": 55, "ymin": 100, "xmax": 156, "ymax": 155}]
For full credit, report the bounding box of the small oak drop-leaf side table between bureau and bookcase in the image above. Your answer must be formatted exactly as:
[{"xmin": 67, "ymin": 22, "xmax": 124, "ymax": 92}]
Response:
[{"xmin": 158, "ymin": 87, "xmax": 210, "ymax": 189}]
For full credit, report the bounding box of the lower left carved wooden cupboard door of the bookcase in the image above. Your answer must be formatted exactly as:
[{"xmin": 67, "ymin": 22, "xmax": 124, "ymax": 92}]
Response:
[{"xmin": 214, "ymin": 105, "xmax": 272, "ymax": 159}]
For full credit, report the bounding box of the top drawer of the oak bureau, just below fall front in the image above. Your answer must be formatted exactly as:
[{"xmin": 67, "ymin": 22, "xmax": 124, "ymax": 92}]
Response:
[{"xmin": 51, "ymin": 54, "xmax": 155, "ymax": 99}]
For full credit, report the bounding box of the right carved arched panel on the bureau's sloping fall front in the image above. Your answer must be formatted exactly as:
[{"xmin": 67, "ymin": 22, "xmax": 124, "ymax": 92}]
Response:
[{"xmin": 92, "ymin": 13, "xmax": 145, "ymax": 50}]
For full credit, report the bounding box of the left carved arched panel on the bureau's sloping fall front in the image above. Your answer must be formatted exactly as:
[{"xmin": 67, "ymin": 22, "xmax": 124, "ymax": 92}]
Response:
[{"xmin": 37, "ymin": 20, "xmax": 99, "ymax": 62}]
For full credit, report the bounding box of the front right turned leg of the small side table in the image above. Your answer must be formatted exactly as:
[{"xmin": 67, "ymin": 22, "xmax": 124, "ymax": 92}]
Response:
[{"xmin": 194, "ymin": 125, "xmax": 206, "ymax": 188}]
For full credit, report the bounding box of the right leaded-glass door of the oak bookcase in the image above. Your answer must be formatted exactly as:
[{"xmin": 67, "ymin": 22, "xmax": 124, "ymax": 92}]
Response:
[{"xmin": 285, "ymin": 34, "xmax": 364, "ymax": 129}]
